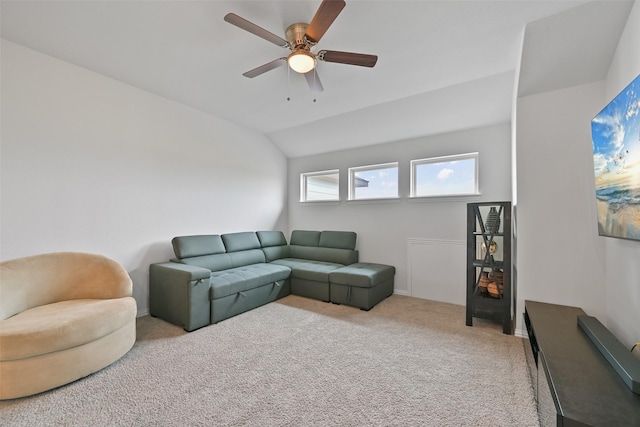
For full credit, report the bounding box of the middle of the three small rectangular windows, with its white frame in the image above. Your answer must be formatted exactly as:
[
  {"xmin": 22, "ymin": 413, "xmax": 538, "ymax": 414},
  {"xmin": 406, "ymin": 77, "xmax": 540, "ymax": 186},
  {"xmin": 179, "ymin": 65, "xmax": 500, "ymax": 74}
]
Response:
[{"xmin": 349, "ymin": 162, "xmax": 398, "ymax": 200}]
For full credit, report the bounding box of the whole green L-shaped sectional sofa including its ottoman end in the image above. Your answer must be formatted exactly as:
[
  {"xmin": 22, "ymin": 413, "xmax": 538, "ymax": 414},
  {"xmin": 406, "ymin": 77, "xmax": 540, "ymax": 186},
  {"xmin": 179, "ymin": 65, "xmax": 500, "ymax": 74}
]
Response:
[{"xmin": 149, "ymin": 230, "xmax": 395, "ymax": 331}]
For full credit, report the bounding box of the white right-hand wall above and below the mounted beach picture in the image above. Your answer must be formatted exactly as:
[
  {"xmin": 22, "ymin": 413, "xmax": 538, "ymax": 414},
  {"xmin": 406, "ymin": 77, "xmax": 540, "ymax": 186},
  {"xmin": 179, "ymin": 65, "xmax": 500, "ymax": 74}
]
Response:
[{"xmin": 600, "ymin": 1, "xmax": 640, "ymax": 347}]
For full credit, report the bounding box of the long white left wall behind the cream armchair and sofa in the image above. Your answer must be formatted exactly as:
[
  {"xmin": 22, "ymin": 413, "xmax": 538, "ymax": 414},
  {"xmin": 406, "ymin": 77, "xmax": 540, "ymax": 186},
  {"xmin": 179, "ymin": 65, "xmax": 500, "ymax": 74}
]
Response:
[{"xmin": 0, "ymin": 40, "xmax": 287, "ymax": 313}]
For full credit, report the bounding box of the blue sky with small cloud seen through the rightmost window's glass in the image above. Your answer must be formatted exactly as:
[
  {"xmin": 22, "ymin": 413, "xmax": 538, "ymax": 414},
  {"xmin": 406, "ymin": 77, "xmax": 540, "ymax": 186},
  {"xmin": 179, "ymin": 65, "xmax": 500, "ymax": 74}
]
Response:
[{"xmin": 414, "ymin": 158, "xmax": 477, "ymax": 197}]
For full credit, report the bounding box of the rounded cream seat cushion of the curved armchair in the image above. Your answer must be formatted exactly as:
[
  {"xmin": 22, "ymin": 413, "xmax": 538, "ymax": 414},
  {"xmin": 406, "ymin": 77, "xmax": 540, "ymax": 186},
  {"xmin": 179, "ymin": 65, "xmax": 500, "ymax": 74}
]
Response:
[{"xmin": 0, "ymin": 297, "xmax": 137, "ymax": 361}]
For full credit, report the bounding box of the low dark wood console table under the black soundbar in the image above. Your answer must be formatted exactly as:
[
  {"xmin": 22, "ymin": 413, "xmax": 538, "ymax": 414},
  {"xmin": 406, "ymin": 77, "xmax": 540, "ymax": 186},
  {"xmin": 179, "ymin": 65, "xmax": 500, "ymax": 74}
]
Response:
[{"xmin": 524, "ymin": 301, "xmax": 640, "ymax": 427}]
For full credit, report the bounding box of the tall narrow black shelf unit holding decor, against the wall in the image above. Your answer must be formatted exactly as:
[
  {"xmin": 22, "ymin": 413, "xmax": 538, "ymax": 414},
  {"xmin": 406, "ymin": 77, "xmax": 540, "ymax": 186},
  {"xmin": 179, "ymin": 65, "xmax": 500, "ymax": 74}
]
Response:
[{"xmin": 466, "ymin": 202, "xmax": 515, "ymax": 334}]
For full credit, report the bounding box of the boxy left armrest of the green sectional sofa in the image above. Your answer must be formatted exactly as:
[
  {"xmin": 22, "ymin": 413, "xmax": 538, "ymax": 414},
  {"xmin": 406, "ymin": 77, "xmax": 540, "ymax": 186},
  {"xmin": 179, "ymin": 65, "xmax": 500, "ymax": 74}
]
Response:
[{"xmin": 149, "ymin": 262, "xmax": 211, "ymax": 331}]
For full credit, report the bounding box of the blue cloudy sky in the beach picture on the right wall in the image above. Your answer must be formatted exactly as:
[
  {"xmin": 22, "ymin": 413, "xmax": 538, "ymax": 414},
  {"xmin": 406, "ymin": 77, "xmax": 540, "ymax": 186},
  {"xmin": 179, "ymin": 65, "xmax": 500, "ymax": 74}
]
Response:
[{"xmin": 591, "ymin": 75, "xmax": 640, "ymax": 187}]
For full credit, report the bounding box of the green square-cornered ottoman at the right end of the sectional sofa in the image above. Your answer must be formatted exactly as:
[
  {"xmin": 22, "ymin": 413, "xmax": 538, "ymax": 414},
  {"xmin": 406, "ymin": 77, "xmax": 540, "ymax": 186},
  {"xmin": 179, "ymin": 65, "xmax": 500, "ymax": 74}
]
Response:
[{"xmin": 329, "ymin": 262, "xmax": 396, "ymax": 311}]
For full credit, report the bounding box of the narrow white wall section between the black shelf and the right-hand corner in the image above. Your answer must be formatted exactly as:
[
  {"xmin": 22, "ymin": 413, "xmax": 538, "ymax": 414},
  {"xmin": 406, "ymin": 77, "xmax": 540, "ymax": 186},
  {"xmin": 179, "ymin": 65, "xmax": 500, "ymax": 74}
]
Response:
[{"xmin": 516, "ymin": 82, "xmax": 606, "ymax": 336}]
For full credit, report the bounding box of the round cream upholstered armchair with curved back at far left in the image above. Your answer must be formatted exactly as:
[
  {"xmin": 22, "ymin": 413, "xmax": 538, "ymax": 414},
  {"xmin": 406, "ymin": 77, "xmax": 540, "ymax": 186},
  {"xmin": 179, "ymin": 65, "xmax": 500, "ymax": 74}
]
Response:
[{"xmin": 0, "ymin": 252, "xmax": 136, "ymax": 399}]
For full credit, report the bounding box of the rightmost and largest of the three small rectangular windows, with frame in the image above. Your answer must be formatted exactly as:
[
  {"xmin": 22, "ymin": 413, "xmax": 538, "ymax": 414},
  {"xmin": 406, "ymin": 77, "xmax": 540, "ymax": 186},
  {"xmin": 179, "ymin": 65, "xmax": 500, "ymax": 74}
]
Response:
[{"xmin": 410, "ymin": 153, "xmax": 479, "ymax": 197}]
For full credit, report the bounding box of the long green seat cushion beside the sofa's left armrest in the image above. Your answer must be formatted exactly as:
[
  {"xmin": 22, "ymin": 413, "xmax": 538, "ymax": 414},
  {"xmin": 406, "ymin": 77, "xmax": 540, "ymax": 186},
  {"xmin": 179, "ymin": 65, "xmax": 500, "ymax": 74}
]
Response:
[{"xmin": 211, "ymin": 263, "xmax": 291, "ymax": 299}]
